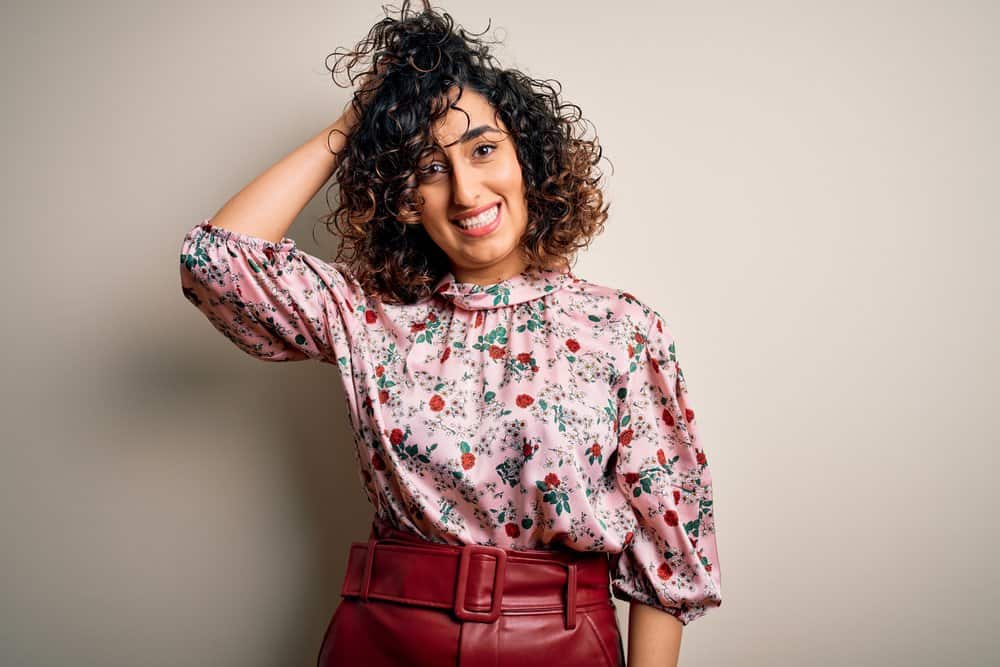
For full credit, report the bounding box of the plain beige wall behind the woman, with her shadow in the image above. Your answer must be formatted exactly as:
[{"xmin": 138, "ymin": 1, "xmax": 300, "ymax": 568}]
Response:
[{"xmin": 0, "ymin": 0, "xmax": 1000, "ymax": 667}]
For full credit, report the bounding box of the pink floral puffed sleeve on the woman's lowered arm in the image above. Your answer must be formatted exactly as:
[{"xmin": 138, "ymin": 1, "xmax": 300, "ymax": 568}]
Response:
[{"xmin": 611, "ymin": 311, "xmax": 722, "ymax": 625}]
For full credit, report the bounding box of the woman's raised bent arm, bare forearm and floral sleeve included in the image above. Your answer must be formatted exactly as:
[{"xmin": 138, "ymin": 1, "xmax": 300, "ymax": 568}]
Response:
[{"xmin": 180, "ymin": 98, "xmax": 371, "ymax": 368}]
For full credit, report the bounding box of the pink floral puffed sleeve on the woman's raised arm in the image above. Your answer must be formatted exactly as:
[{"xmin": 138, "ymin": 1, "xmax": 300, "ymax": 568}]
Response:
[{"xmin": 180, "ymin": 219, "xmax": 365, "ymax": 365}]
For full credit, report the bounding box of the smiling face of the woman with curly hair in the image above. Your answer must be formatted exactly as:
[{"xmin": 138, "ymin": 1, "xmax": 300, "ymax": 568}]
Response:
[{"xmin": 417, "ymin": 87, "xmax": 528, "ymax": 285}]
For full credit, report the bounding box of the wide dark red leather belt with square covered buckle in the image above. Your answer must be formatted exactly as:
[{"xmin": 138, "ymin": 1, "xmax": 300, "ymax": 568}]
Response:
[{"xmin": 340, "ymin": 519, "xmax": 614, "ymax": 629}]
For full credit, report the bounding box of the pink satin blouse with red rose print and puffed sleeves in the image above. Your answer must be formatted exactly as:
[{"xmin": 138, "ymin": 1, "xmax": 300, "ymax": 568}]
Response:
[{"xmin": 180, "ymin": 219, "xmax": 722, "ymax": 625}]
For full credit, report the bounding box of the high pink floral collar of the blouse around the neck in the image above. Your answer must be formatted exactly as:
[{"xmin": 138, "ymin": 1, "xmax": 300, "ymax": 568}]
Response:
[{"xmin": 433, "ymin": 268, "xmax": 575, "ymax": 310}]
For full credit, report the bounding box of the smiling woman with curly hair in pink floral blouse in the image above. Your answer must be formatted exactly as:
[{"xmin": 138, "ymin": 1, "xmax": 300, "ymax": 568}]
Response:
[{"xmin": 181, "ymin": 3, "xmax": 721, "ymax": 667}]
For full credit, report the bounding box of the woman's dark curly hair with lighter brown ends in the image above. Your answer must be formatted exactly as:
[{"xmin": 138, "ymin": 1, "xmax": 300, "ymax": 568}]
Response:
[{"xmin": 320, "ymin": 0, "xmax": 609, "ymax": 303}]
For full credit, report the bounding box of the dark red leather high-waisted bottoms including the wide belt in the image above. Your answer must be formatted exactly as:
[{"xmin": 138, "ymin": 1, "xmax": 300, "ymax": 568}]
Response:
[{"xmin": 317, "ymin": 516, "xmax": 625, "ymax": 667}]
